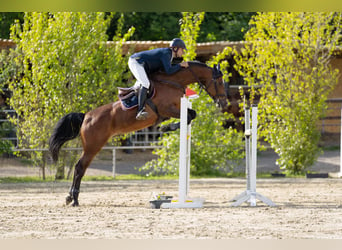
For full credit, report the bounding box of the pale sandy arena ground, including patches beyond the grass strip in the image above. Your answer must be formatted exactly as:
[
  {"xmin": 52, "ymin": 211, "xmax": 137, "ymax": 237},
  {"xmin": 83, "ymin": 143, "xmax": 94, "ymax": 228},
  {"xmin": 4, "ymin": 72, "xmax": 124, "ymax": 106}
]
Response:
[{"xmin": 0, "ymin": 148, "xmax": 342, "ymax": 239}]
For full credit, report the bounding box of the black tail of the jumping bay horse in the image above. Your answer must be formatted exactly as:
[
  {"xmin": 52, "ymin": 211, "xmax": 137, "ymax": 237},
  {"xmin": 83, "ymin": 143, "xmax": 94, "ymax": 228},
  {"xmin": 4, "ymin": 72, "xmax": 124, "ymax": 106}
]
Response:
[{"xmin": 49, "ymin": 113, "xmax": 85, "ymax": 162}]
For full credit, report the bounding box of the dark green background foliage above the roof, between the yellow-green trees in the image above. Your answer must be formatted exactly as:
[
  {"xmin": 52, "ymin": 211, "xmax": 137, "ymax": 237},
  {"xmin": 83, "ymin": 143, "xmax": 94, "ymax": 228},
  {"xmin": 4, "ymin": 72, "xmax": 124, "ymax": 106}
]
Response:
[{"xmin": 104, "ymin": 12, "xmax": 255, "ymax": 42}]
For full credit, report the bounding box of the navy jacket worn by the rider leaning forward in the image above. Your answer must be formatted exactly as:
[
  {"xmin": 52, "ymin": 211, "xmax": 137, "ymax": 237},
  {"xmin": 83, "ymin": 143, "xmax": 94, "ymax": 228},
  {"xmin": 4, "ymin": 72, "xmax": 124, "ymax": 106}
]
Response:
[{"xmin": 131, "ymin": 48, "xmax": 181, "ymax": 75}]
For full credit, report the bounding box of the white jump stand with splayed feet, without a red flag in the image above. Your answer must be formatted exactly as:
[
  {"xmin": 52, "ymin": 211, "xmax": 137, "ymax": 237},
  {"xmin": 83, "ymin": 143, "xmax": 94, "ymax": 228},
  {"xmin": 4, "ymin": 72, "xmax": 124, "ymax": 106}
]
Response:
[{"xmin": 230, "ymin": 105, "xmax": 275, "ymax": 207}]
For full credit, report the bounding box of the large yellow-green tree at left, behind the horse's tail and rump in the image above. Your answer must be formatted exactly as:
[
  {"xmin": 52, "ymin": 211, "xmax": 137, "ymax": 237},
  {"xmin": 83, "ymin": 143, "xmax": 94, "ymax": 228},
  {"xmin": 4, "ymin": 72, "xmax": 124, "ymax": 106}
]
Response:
[{"xmin": 10, "ymin": 12, "xmax": 134, "ymax": 179}]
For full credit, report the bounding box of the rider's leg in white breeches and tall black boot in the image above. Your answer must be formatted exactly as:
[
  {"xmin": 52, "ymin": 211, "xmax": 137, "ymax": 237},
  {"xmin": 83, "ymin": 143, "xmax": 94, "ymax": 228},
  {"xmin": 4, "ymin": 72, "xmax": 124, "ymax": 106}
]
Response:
[{"xmin": 128, "ymin": 58, "xmax": 150, "ymax": 120}]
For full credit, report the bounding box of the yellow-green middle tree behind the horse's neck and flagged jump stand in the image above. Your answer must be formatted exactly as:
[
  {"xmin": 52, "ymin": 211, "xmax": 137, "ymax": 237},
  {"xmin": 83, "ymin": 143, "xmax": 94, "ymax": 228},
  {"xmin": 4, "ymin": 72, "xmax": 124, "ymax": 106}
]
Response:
[{"xmin": 141, "ymin": 12, "xmax": 244, "ymax": 176}]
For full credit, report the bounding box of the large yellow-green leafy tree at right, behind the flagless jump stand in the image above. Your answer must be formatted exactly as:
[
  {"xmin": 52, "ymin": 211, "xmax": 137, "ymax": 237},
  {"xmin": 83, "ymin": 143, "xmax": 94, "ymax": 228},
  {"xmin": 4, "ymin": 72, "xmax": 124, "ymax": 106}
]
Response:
[{"xmin": 237, "ymin": 12, "xmax": 342, "ymax": 174}]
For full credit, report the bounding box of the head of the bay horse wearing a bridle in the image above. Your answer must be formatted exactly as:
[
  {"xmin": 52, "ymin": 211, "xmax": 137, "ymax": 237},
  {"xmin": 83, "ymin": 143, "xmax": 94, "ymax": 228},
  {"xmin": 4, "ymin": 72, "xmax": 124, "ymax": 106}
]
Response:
[{"xmin": 200, "ymin": 65, "xmax": 228, "ymax": 109}]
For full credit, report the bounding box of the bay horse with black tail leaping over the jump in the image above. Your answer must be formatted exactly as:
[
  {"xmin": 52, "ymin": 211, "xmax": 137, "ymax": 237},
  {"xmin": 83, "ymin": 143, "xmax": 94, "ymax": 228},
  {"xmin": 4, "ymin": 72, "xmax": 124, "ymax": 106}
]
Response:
[{"xmin": 49, "ymin": 62, "xmax": 228, "ymax": 206}]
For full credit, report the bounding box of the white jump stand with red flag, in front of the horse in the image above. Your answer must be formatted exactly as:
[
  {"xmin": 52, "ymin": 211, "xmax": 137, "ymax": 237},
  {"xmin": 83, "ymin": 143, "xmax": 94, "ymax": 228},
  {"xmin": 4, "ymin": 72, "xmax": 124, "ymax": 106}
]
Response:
[{"xmin": 161, "ymin": 91, "xmax": 204, "ymax": 208}]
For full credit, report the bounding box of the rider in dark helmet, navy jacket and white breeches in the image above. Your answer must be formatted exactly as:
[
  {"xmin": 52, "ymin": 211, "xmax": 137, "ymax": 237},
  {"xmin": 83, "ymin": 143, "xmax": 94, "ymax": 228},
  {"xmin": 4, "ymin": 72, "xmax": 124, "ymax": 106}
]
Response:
[{"xmin": 128, "ymin": 38, "xmax": 189, "ymax": 120}]
